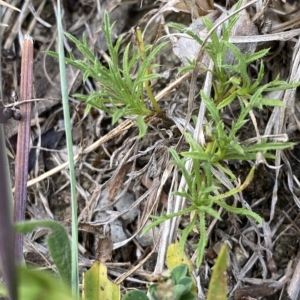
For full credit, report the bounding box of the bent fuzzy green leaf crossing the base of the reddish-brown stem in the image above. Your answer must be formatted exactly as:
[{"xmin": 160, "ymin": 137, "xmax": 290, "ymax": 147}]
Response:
[{"xmin": 15, "ymin": 220, "xmax": 71, "ymax": 286}]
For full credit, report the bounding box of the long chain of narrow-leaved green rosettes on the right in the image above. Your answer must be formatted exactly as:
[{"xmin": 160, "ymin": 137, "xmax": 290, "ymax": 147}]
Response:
[{"xmin": 143, "ymin": 6, "xmax": 299, "ymax": 267}]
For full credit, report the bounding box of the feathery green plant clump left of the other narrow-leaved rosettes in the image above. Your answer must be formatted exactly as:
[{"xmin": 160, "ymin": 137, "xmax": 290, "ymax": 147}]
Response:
[{"xmin": 47, "ymin": 12, "xmax": 167, "ymax": 137}]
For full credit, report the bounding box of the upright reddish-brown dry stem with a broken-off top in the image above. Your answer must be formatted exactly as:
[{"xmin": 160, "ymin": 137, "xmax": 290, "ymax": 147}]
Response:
[{"xmin": 14, "ymin": 35, "xmax": 33, "ymax": 263}]
